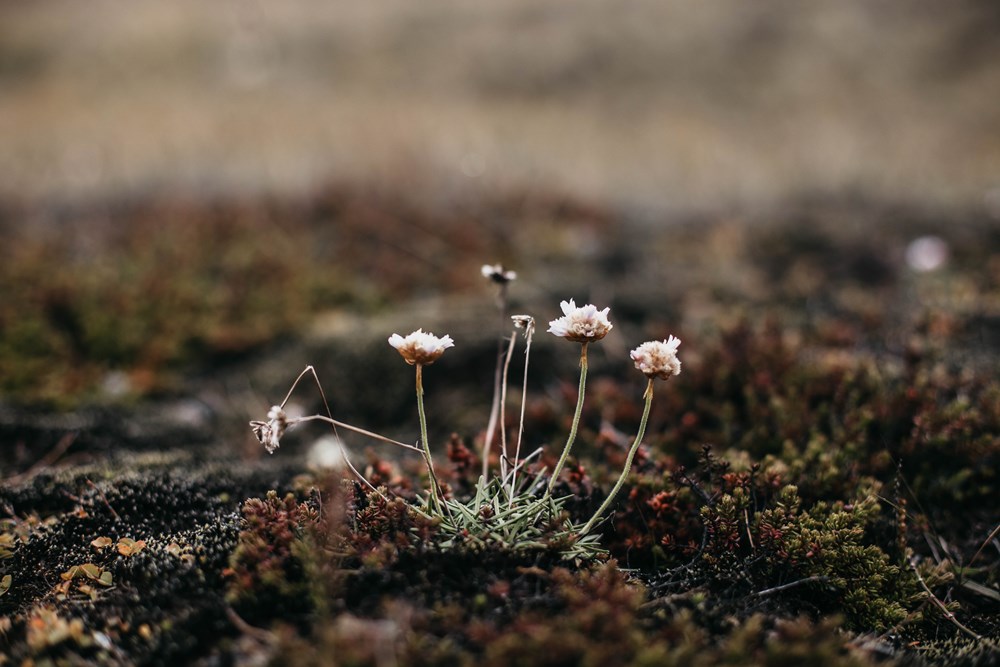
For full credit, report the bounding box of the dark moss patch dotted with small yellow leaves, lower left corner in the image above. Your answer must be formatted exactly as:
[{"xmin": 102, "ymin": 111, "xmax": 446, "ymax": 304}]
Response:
[{"xmin": 0, "ymin": 454, "xmax": 304, "ymax": 664}]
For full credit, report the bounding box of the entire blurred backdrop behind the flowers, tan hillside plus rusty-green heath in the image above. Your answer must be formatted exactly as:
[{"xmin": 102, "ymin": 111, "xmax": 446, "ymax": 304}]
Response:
[{"xmin": 0, "ymin": 0, "xmax": 1000, "ymax": 464}]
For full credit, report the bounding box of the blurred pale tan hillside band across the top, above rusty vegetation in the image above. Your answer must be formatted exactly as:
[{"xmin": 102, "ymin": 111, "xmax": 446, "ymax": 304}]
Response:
[{"xmin": 0, "ymin": 0, "xmax": 1000, "ymax": 208}]
